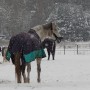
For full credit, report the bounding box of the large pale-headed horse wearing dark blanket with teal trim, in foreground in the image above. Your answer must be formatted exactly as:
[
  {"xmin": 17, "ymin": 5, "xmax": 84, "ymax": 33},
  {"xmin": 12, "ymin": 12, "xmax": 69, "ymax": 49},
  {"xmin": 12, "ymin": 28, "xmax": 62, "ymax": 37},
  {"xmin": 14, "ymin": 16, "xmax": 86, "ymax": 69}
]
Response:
[{"xmin": 6, "ymin": 22, "xmax": 59, "ymax": 83}]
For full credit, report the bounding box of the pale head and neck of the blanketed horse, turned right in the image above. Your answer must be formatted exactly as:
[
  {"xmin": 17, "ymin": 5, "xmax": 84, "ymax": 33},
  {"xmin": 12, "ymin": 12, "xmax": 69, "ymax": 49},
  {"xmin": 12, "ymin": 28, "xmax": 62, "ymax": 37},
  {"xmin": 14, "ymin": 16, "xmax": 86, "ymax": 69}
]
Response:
[{"xmin": 32, "ymin": 22, "xmax": 60, "ymax": 43}]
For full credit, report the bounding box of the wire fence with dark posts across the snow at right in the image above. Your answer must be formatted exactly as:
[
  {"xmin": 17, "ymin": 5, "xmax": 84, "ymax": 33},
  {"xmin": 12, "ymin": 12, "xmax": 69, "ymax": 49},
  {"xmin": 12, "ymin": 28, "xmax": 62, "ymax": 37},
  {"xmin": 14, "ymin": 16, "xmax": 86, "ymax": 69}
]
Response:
[{"xmin": 56, "ymin": 44, "xmax": 90, "ymax": 55}]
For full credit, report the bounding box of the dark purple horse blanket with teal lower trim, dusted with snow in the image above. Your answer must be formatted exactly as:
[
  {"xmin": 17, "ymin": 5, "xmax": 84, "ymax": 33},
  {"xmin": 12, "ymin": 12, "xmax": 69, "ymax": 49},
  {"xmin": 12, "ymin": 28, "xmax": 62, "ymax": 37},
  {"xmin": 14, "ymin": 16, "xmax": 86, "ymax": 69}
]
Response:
[{"xmin": 6, "ymin": 30, "xmax": 46, "ymax": 62}]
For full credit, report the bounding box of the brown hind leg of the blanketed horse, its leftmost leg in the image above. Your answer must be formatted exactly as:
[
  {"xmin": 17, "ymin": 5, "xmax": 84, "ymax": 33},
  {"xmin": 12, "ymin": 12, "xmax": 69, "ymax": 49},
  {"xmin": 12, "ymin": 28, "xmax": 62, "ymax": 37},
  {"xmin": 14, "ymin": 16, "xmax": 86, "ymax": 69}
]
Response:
[{"xmin": 15, "ymin": 53, "xmax": 21, "ymax": 83}]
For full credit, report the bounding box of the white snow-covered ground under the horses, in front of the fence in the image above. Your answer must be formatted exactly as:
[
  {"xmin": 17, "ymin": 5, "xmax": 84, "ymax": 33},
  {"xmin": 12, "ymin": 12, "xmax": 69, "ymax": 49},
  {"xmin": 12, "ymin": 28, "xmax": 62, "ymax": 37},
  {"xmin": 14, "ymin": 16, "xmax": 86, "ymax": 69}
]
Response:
[{"xmin": 0, "ymin": 53, "xmax": 90, "ymax": 90}]
